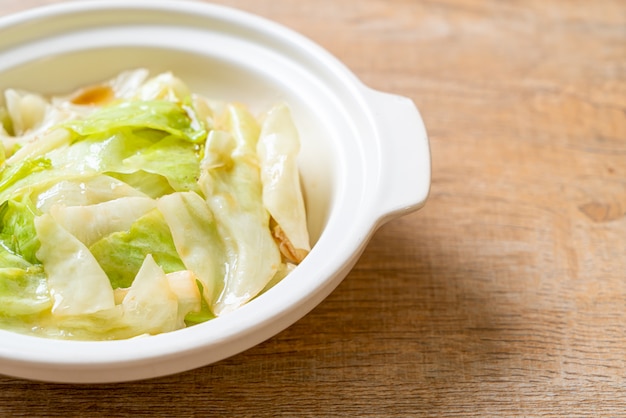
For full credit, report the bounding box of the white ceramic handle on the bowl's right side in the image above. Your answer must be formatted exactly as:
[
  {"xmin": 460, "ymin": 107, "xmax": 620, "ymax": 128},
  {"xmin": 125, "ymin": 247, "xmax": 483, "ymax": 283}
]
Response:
[{"xmin": 366, "ymin": 89, "xmax": 431, "ymax": 224}]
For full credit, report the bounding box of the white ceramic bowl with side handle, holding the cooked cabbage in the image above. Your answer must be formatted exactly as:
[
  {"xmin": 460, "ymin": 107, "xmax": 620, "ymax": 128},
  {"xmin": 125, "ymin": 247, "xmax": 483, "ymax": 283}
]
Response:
[{"xmin": 0, "ymin": 0, "xmax": 430, "ymax": 382}]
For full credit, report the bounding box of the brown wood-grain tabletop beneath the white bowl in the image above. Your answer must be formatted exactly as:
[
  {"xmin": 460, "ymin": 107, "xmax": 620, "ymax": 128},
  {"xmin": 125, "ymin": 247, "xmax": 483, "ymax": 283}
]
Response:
[{"xmin": 0, "ymin": 0, "xmax": 626, "ymax": 417}]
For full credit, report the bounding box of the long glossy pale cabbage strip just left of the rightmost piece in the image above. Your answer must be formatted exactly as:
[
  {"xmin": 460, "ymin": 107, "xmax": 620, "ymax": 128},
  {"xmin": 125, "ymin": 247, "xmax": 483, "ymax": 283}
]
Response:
[{"xmin": 199, "ymin": 105, "xmax": 281, "ymax": 316}]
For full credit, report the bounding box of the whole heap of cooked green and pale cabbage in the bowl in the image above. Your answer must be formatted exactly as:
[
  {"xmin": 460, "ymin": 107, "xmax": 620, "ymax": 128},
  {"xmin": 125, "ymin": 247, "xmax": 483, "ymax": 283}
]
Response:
[{"xmin": 0, "ymin": 69, "xmax": 310, "ymax": 340}]
